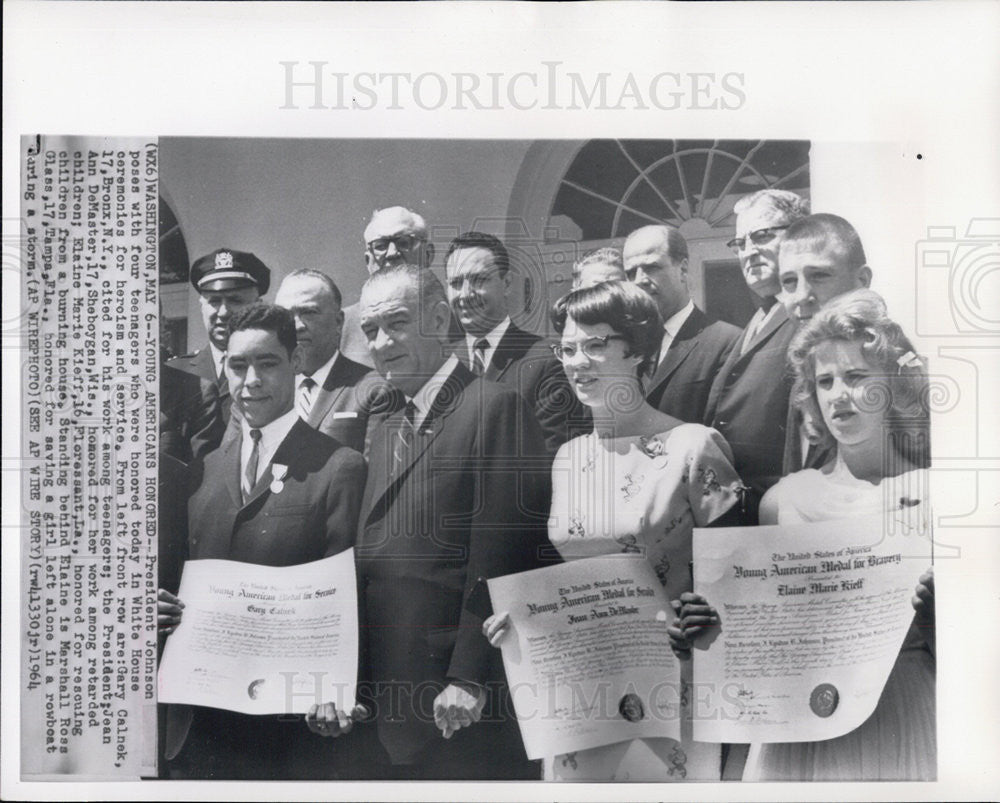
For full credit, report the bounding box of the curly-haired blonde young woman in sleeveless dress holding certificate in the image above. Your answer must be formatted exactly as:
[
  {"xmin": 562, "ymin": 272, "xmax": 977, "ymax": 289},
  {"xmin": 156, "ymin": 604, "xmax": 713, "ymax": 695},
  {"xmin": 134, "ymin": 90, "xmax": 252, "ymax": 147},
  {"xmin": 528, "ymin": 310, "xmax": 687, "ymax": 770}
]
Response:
[{"xmin": 672, "ymin": 290, "xmax": 937, "ymax": 781}]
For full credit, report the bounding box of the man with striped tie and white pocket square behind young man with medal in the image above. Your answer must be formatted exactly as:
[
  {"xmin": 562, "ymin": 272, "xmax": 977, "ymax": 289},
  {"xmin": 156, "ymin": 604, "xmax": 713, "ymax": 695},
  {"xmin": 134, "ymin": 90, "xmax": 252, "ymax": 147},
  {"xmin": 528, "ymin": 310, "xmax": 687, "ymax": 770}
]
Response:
[{"xmin": 274, "ymin": 269, "xmax": 398, "ymax": 454}]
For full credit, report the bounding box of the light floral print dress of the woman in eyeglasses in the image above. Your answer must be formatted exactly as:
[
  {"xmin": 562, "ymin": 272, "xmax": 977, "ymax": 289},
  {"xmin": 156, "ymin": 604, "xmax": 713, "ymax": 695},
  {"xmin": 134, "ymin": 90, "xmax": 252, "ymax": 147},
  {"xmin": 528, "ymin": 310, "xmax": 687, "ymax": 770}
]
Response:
[{"xmin": 544, "ymin": 424, "xmax": 743, "ymax": 781}]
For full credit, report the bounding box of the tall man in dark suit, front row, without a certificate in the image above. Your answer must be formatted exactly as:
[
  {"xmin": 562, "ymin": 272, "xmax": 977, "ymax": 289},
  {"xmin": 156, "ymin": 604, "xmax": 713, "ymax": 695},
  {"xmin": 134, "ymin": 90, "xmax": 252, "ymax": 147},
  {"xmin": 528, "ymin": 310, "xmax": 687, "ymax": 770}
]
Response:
[{"xmin": 307, "ymin": 266, "xmax": 554, "ymax": 780}]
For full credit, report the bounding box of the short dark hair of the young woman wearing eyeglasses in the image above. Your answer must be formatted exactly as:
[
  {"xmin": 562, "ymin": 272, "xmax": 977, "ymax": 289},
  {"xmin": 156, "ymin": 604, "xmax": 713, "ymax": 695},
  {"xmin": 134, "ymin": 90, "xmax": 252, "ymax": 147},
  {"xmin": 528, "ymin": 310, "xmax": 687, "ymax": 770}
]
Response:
[{"xmin": 552, "ymin": 281, "xmax": 663, "ymax": 373}]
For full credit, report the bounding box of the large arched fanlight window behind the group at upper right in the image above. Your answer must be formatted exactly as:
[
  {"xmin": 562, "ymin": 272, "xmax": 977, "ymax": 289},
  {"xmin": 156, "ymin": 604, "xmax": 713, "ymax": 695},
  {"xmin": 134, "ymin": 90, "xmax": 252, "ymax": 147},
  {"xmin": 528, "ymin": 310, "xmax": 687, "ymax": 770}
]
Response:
[{"xmin": 509, "ymin": 139, "xmax": 810, "ymax": 331}]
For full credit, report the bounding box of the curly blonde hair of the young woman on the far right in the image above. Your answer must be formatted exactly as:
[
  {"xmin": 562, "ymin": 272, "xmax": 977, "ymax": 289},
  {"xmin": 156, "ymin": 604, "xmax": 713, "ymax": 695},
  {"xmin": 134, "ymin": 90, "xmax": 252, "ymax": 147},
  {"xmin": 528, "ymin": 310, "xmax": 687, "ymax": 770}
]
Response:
[{"xmin": 788, "ymin": 289, "xmax": 930, "ymax": 468}]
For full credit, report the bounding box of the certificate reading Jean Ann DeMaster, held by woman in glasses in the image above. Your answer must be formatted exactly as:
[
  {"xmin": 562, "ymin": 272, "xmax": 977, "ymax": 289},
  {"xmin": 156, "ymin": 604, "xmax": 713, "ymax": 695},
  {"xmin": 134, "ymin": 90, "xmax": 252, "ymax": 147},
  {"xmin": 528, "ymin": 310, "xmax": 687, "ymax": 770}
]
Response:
[{"xmin": 489, "ymin": 555, "xmax": 680, "ymax": 759}]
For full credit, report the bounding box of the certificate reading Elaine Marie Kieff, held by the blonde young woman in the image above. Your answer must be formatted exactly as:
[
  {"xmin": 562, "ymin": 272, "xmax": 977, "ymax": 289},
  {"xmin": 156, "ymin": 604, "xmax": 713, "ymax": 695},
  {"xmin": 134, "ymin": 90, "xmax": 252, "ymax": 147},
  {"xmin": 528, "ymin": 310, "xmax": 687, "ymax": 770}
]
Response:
[{"xmin": 693, "ymin": 513, "xmax": 929, "ymax": 742}]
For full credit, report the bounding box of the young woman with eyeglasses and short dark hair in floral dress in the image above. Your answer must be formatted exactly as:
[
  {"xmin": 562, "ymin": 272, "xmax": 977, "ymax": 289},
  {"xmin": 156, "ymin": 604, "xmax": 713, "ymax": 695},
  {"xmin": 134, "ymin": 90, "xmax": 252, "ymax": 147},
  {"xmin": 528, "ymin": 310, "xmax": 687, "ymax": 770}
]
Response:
[{"xmin": 483, "ymin": 281, "xmax": 742, "ymax": 781}]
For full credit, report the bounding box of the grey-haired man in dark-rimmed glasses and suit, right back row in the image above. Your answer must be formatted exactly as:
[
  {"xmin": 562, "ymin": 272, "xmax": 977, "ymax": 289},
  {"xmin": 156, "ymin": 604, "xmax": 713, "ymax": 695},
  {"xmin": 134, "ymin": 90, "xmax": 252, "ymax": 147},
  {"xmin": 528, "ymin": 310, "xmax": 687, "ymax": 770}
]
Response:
[{"xmin": 705, "ymin": 190, "xmax": 809, "ymax": 524}]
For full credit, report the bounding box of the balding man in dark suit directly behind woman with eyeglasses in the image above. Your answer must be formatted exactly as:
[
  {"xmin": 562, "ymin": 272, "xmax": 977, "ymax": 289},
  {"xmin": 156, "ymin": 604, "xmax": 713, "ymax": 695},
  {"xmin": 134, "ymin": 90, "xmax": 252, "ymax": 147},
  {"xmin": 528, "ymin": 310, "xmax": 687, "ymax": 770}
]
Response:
[{"xmin": 622, "ymin": 226, "xmax": 740, "ymax": 424}]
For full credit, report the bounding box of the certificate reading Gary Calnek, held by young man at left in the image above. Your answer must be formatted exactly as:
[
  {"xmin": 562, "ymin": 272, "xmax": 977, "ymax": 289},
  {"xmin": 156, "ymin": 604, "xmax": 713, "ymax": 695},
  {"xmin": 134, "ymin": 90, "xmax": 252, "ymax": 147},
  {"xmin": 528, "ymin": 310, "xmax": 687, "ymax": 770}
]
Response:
[{"xmin": 159, "ymin": 549, "xmax": 358, "ymax": 714}]
